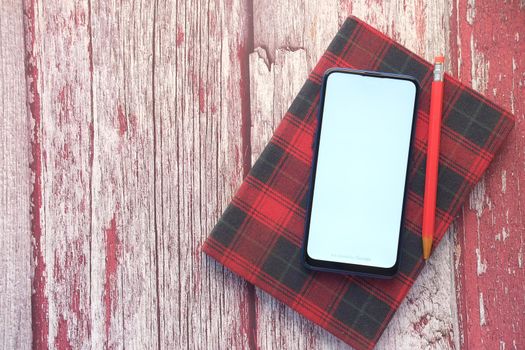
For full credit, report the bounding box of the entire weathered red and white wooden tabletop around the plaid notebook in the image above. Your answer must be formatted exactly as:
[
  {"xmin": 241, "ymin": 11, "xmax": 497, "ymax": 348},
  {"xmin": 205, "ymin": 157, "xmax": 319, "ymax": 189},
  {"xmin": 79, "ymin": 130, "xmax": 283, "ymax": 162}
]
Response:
[{"xmin": 0, "ymin": 0, "xmax": 525, "ymax": 349}]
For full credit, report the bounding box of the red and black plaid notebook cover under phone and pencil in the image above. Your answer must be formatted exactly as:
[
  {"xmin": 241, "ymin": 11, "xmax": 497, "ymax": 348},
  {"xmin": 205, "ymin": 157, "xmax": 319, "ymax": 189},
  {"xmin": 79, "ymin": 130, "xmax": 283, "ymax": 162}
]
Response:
[{"xmin": 203, "ymin": 17, "xmax": 514, "ymax": 349}]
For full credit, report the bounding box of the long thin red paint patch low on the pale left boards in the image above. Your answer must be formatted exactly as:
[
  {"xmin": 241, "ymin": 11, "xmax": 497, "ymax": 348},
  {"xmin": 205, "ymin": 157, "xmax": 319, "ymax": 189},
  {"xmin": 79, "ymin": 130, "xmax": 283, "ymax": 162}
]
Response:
[{"xmin": 104, "ymin": 215, "xmax": 120, "ymax": 345}]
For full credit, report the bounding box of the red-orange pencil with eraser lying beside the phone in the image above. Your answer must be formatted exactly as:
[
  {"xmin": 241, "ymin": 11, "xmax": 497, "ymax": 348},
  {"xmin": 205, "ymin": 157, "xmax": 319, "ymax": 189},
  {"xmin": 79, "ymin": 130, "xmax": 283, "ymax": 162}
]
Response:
[{"xmin": 422, "ymin": 56, "xmax": 445, "ymax": 260}]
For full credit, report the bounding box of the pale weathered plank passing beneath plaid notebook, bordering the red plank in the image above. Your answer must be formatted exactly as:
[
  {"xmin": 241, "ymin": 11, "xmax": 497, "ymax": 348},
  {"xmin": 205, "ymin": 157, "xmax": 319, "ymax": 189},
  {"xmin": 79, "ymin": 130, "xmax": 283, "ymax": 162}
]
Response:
[{"xmin": 250, "ymin": 1, "xmax": 458, "ymax": 349}]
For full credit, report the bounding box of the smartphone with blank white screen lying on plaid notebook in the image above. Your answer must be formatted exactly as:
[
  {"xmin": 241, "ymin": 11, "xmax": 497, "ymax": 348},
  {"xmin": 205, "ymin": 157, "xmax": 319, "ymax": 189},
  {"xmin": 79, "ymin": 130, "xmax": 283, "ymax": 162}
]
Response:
[{"xmin": 303, "ymin": 68, "xmax": 419, "ymax": 278}]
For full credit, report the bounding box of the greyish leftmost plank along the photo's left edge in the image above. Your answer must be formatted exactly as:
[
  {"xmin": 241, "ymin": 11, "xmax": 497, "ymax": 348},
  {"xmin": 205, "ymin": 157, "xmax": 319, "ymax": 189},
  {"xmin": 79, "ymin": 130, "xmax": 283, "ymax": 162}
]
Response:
[{"xmin": 0, "ymin": 1, "xmax": 31, "ymax": 349}]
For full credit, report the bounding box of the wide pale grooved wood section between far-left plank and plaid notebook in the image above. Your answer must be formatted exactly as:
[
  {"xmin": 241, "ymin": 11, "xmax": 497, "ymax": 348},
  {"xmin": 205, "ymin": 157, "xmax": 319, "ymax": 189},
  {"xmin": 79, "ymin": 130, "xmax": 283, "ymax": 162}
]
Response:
[{"xmin": 25, "ymin": 1, "xmax": 249, "ymax": 348}]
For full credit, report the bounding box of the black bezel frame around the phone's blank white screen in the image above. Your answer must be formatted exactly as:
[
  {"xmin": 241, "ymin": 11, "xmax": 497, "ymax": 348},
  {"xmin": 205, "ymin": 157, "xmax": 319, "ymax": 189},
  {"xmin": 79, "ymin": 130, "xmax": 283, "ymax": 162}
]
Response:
[{"xmin": 302, "ymin": 68, "xmax": 420, "ymax": 278}]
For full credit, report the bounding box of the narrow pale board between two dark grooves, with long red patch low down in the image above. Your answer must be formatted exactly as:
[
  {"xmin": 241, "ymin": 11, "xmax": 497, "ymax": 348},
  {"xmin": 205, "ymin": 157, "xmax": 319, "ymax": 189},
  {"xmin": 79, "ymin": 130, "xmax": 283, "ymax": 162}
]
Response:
[{"xmin": 90, "ymin": 1, "xmax": 160, "ymax": 349}]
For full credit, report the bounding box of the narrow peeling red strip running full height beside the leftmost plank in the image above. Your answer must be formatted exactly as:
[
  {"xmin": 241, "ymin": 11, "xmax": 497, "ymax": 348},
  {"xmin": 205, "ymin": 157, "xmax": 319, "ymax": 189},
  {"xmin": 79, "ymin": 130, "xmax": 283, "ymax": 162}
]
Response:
[{"xmin": 24, "ymin": 1, "xmax": 49, "ymax": 349}]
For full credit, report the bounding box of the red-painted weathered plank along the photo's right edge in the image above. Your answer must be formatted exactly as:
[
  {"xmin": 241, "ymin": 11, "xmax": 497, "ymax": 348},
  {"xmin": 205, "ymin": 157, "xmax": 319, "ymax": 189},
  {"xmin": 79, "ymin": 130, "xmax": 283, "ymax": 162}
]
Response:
[{"xmin": 451, "ymin": 0, "xmax": 525, "ymax": 349}]
